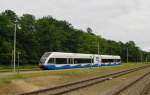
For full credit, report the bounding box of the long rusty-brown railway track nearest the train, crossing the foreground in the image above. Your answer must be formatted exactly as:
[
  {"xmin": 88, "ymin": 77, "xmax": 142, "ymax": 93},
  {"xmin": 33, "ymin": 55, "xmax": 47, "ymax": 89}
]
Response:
[{"xmin": 19, "ymin": 65, "xmax": 150, "ymax": 95}]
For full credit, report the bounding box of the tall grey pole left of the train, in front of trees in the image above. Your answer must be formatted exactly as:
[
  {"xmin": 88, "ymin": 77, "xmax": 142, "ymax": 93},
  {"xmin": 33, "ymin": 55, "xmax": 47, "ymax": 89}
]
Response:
[{"xmin": 13, "ymin": 21, "xmax": 17, "ymax": 72}]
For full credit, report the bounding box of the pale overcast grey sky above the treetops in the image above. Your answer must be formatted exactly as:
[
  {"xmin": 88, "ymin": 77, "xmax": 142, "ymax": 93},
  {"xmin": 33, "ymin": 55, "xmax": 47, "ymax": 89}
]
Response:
[{"xmin": 0, "ymin": 0, "xmax": 150, "ymax": 51}]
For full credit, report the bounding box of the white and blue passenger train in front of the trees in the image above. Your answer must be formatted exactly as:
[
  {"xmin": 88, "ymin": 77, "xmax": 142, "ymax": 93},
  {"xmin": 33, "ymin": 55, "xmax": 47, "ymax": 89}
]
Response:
[{"xmin": 39, "ymin": 52, "xmax": 121, "ymax": 70}]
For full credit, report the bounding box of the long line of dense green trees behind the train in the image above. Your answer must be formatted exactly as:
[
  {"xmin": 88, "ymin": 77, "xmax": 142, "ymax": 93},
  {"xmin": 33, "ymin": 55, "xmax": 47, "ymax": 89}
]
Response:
[{"xmin": 0, "ymin": 10, "xmax": 150, "ymax": 65}]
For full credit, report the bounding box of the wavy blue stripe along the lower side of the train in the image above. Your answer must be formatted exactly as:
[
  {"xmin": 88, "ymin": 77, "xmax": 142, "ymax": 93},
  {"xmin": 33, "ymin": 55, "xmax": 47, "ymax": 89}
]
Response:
[{"xmin": 42, "ymin": 64, "xmax": 120, "ymax": 70}]
